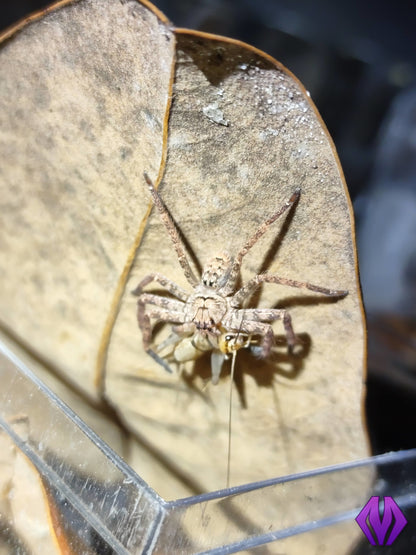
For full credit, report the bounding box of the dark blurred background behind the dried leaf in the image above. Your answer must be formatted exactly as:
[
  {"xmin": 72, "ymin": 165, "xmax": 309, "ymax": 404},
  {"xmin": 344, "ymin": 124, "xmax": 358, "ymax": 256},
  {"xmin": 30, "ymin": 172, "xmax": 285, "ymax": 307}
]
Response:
[{"xmin": 0, "ymin": 0, "xmax": 416, "ymax": 548}]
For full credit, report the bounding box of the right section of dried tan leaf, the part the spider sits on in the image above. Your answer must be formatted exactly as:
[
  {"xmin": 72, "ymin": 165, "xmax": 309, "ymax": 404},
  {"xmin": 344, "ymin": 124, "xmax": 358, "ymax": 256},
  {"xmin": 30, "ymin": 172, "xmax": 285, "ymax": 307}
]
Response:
[{"xmin": 106, "ymin": 28, "xmax": 366, "ymax": 498}]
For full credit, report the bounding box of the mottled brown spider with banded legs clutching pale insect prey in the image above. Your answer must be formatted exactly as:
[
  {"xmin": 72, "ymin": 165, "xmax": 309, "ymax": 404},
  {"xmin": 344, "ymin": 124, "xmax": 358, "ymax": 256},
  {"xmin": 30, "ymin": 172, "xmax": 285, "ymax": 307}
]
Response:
[{"xmin": 132, "ymin": 173, "xmax": 348, "ymax": 384}]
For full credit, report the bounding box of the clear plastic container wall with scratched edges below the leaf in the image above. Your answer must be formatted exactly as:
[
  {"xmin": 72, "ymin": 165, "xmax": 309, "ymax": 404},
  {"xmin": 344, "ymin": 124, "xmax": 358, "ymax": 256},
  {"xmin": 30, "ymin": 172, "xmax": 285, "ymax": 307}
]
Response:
[{"xmin": 0, "ymin": 344, "xmax": 416, "ymax": 554}]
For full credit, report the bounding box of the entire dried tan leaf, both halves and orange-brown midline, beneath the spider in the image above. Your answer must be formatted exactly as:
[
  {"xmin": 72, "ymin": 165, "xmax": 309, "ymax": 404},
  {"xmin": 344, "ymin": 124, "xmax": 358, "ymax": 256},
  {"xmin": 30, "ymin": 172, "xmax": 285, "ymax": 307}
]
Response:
[{"xmin": 0, "ymin": 0, "xmax": 367, "ymax": 510}]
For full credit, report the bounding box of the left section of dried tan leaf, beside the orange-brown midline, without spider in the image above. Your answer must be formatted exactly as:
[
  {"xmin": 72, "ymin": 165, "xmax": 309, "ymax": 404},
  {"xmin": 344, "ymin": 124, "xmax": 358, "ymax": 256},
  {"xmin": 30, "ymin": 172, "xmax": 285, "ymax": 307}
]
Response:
[{"xmin": 0, "ymin": 1, "xmax": 173, "ymax": 396}]
